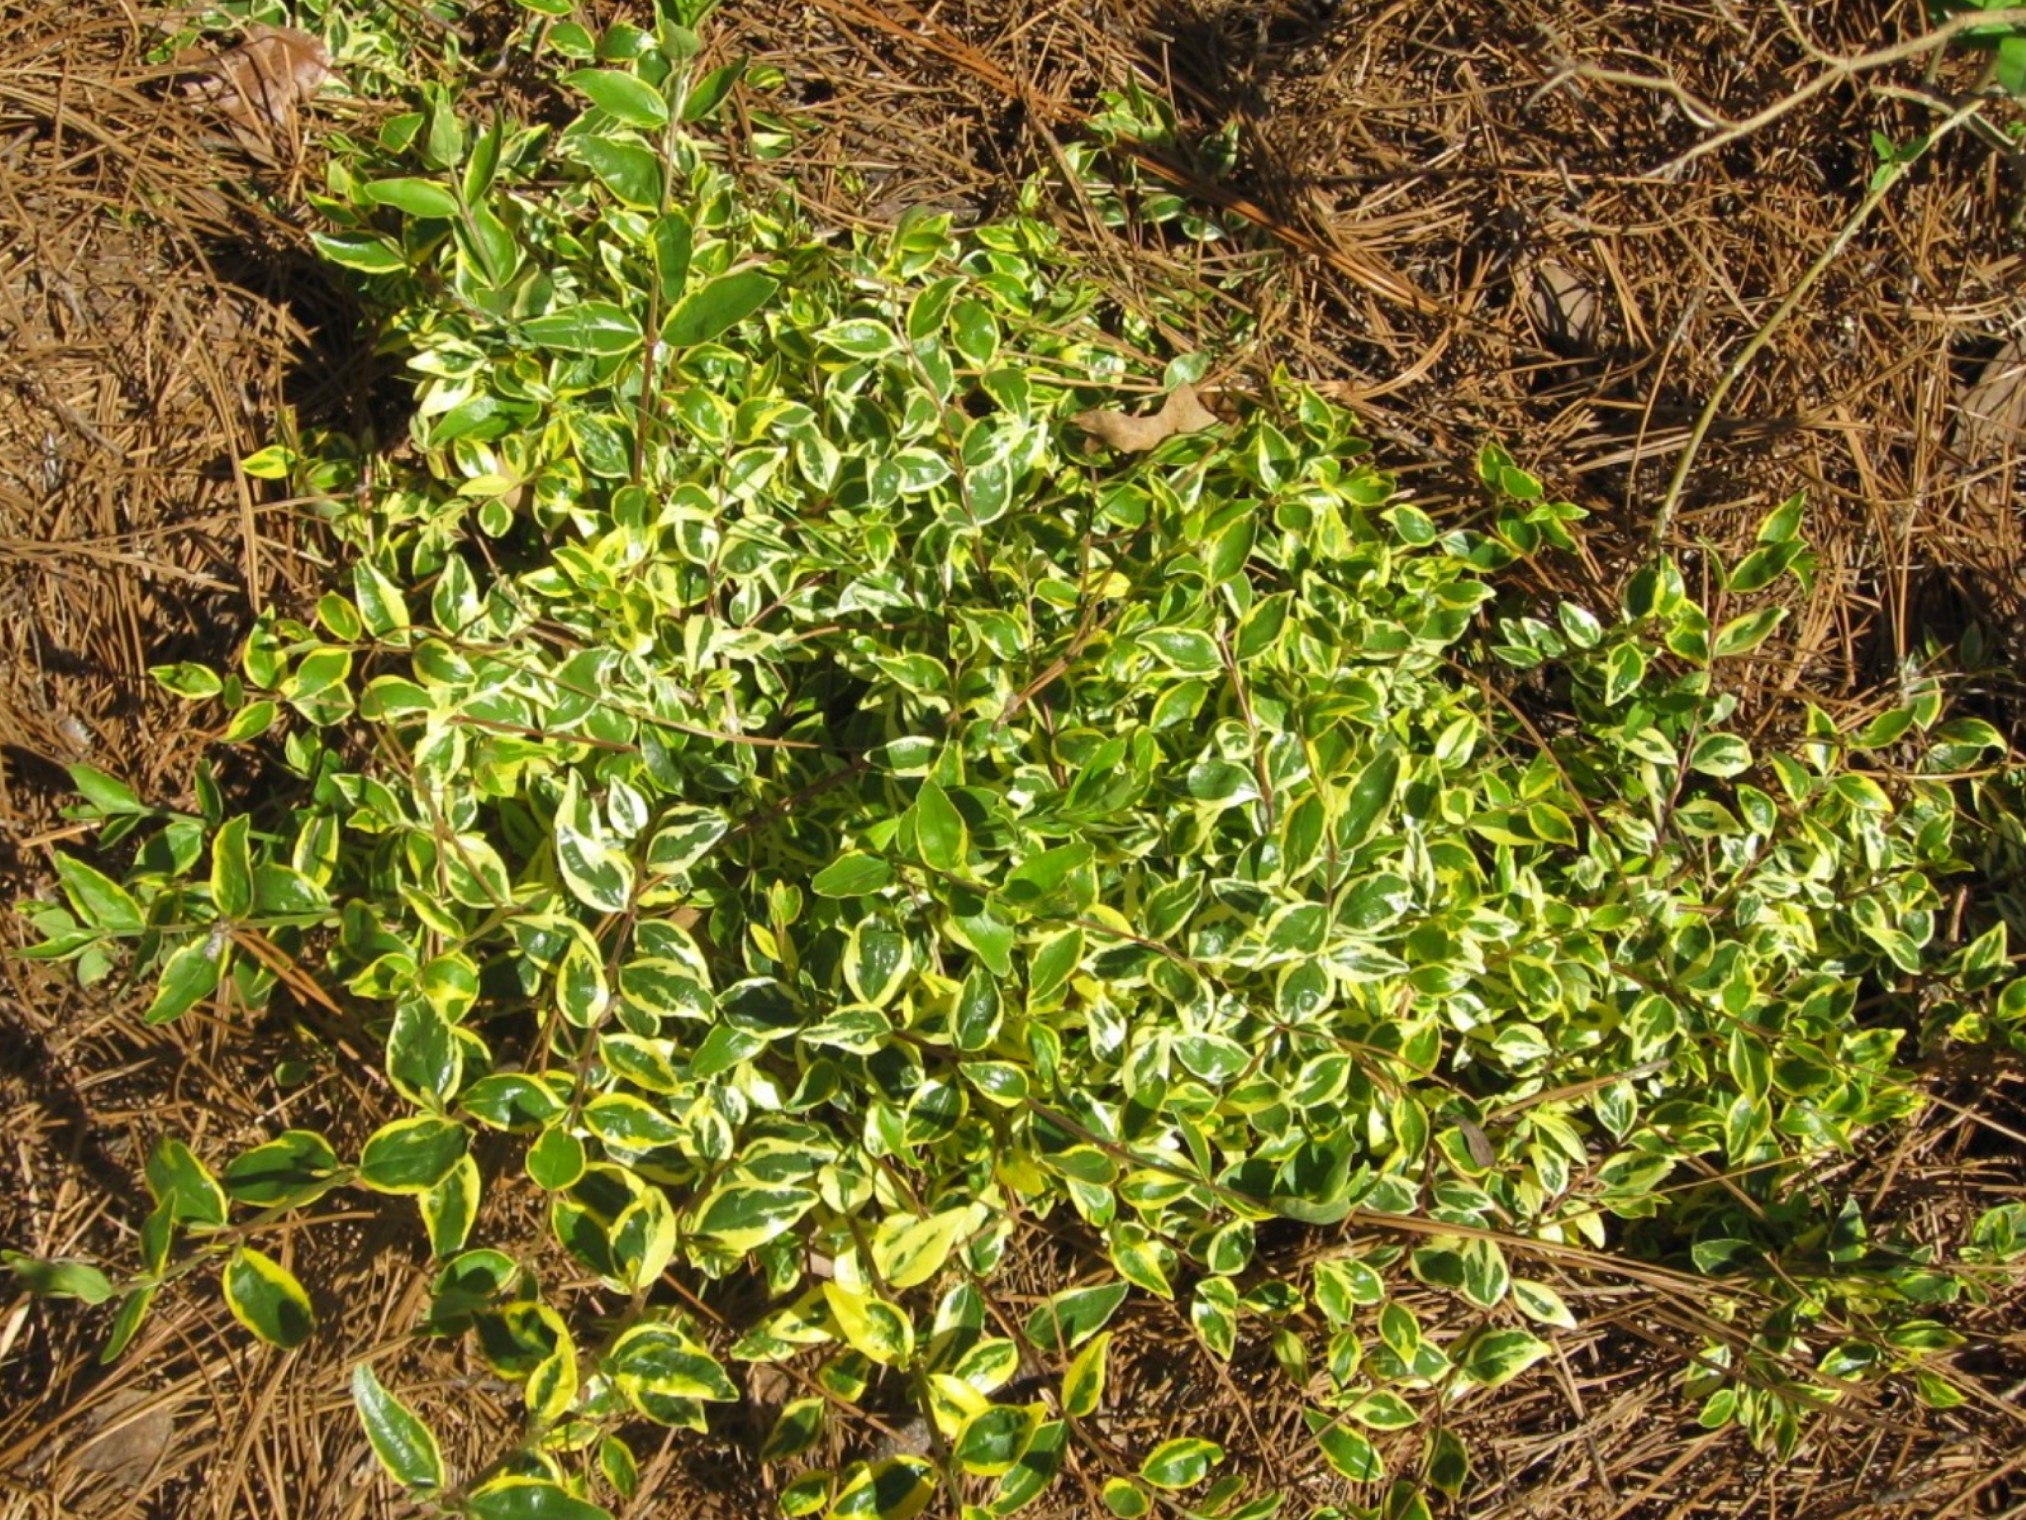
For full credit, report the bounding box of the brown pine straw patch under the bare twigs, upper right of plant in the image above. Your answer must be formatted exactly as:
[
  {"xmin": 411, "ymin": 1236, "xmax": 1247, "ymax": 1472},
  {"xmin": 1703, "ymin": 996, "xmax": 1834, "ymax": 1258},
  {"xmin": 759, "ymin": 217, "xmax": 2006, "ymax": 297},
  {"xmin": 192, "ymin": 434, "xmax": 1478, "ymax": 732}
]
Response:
[{"xmin": 727, "ymin": 0, "xmax": 2026, "ymax": 733}]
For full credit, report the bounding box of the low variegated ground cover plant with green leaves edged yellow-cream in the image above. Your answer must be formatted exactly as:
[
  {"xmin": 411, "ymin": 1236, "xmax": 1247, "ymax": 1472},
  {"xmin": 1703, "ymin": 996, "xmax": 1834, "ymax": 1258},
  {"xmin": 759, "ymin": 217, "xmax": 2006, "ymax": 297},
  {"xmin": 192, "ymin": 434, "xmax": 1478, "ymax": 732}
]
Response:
[{"xmin": 14, "ymin": 8, "xmax": 2026, "ymax": 1518}]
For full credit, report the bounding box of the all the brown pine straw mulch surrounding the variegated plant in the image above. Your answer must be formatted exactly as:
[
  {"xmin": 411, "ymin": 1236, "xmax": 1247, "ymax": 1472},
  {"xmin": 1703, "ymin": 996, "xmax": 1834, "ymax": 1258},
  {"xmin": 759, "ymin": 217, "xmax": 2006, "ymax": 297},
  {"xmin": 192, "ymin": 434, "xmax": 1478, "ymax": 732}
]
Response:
[{"xmin": 0, "ymin": 0, "xmax": 2026, "ymax": 1520}]
